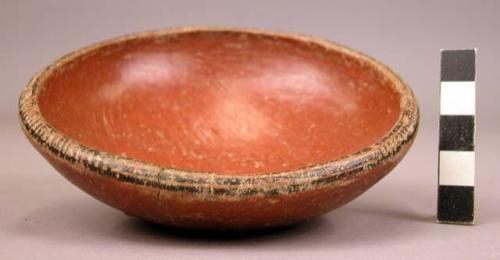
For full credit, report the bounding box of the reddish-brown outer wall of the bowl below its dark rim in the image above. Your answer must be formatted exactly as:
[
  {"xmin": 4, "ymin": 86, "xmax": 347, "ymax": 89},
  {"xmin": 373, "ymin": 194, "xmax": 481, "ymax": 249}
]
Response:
[{"xmin": 33, "ymin": 136, "xmax": 411, "ymax": 229}]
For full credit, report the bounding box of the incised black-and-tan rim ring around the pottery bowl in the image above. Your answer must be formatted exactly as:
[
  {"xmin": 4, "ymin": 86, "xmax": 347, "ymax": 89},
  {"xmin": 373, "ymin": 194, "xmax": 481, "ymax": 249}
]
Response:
[{"xmin": 19, "ymin": 26, "xmax": 419, "ymax": 198}]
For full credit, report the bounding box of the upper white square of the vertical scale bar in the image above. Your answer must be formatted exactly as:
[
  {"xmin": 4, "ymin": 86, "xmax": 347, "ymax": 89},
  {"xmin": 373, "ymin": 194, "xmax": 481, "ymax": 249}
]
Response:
[{"xmin": 441, "ymin": 81, "xmax": 476, "ymax": 115}]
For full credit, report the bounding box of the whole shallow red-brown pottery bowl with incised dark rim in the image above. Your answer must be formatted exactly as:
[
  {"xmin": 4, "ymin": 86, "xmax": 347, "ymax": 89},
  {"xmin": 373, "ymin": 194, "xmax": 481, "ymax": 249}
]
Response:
[{"xmin": 19, "ymin": 28, "xmax": 418, "ymax": 229}]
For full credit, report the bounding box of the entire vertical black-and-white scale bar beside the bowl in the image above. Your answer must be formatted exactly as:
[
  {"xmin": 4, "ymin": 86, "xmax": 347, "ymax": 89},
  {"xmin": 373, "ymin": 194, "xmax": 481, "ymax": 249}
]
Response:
[{"xmin": 437, "ymin": 49, "xmax": 476, "ymax": 224}]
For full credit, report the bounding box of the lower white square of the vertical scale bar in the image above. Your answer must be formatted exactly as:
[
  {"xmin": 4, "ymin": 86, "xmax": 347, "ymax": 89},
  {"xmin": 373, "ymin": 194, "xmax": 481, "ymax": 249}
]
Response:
[{"xmin": 439, "ymin": 151, "xmax": 475, "ymax": 186}]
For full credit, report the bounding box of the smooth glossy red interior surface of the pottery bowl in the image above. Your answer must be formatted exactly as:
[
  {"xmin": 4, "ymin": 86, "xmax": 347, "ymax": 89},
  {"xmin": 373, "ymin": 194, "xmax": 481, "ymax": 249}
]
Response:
[{"xmin": 38, "ymin": 31, "xmax": 400, "ymax": 175}]
